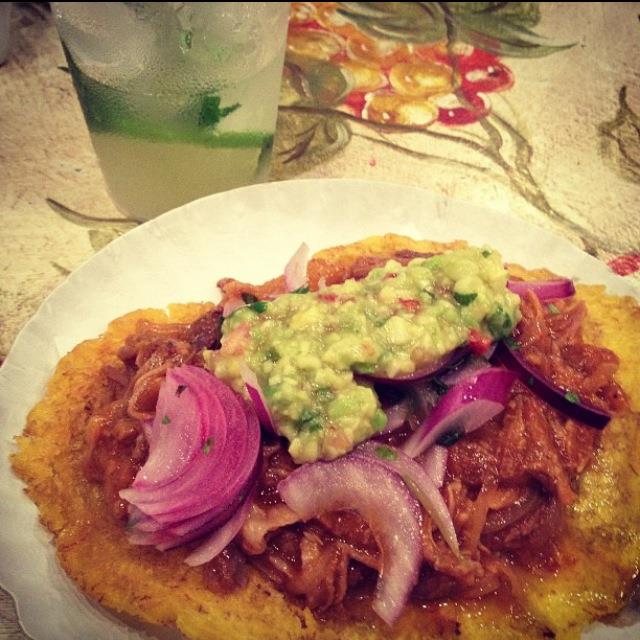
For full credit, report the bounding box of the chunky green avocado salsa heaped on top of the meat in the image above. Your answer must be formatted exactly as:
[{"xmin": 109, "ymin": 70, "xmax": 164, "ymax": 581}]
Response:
[{"xmin": 206, "ymin": 248, "xmax": 520, "ymax": 463}]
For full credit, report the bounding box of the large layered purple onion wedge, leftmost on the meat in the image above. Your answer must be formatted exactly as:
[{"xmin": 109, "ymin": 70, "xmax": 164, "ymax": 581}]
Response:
[{"xmin": 120, "ymin": 365, "xmax": 260, "ymax": 553}]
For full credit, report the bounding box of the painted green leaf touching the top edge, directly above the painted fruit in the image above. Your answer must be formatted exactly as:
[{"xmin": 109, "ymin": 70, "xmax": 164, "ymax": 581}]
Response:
[{"xmin": 338, "ymin": 2, "xmax": 447, "ymax": 43}]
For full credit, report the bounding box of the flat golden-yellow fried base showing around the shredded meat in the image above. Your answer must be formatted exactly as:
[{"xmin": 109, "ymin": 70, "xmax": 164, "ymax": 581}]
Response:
[{"xmin": 13, "ymin": 236, "xmax": 640, "ymax": 640}]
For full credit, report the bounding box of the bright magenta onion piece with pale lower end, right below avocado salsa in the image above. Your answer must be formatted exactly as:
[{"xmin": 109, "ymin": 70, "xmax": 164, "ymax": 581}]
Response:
[{"xmin": 402, "ymin": 367, "xmax": 517, "ymax": 458}]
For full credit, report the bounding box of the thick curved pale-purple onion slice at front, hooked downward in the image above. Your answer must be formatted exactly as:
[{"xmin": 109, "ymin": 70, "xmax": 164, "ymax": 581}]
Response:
[{"xmin": 278, "ymin": 455, "xmax": 422, "ymax": 625}]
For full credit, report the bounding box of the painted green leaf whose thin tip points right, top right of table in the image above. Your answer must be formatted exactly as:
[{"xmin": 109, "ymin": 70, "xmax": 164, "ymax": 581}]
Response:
[{"xmin": 455, "ymin": 13, "xmax": 573, "ymax": 58}]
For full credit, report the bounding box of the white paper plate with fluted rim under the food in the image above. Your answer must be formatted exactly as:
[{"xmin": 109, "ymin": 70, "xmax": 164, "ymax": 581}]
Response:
[{"xmin": 0, "ymin": 180, "xmax": 640, "ymax": 640}]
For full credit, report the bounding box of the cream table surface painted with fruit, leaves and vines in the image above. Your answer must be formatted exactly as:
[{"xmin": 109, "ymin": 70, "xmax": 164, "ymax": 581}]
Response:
[{"xmin": 0, "ymin": 2, "xmax": 640, "ymax": 638}]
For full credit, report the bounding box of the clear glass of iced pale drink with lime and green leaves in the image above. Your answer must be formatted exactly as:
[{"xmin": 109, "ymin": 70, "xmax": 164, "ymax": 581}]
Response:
[{"xmin": 53, "ymin": 2, "xmax": 289, "ymax": 220}]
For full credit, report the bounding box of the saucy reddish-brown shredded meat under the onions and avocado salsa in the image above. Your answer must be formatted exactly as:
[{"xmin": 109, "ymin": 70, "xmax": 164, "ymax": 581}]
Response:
[{"xmin": 81, "ymin": 278, "xmax": 625, "ymax": 612}]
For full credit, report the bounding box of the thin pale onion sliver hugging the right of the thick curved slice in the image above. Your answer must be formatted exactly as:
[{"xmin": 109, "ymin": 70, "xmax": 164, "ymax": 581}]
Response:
[{"xmin": 354, "ymin": 442, "xmax": 460, "ymax": 554}]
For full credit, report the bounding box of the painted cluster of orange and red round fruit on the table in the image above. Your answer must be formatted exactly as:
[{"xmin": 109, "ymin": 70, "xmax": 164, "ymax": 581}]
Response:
[{"xmin": 288, "ymin": 2, "xmax": 514, "ymax": 127}]
